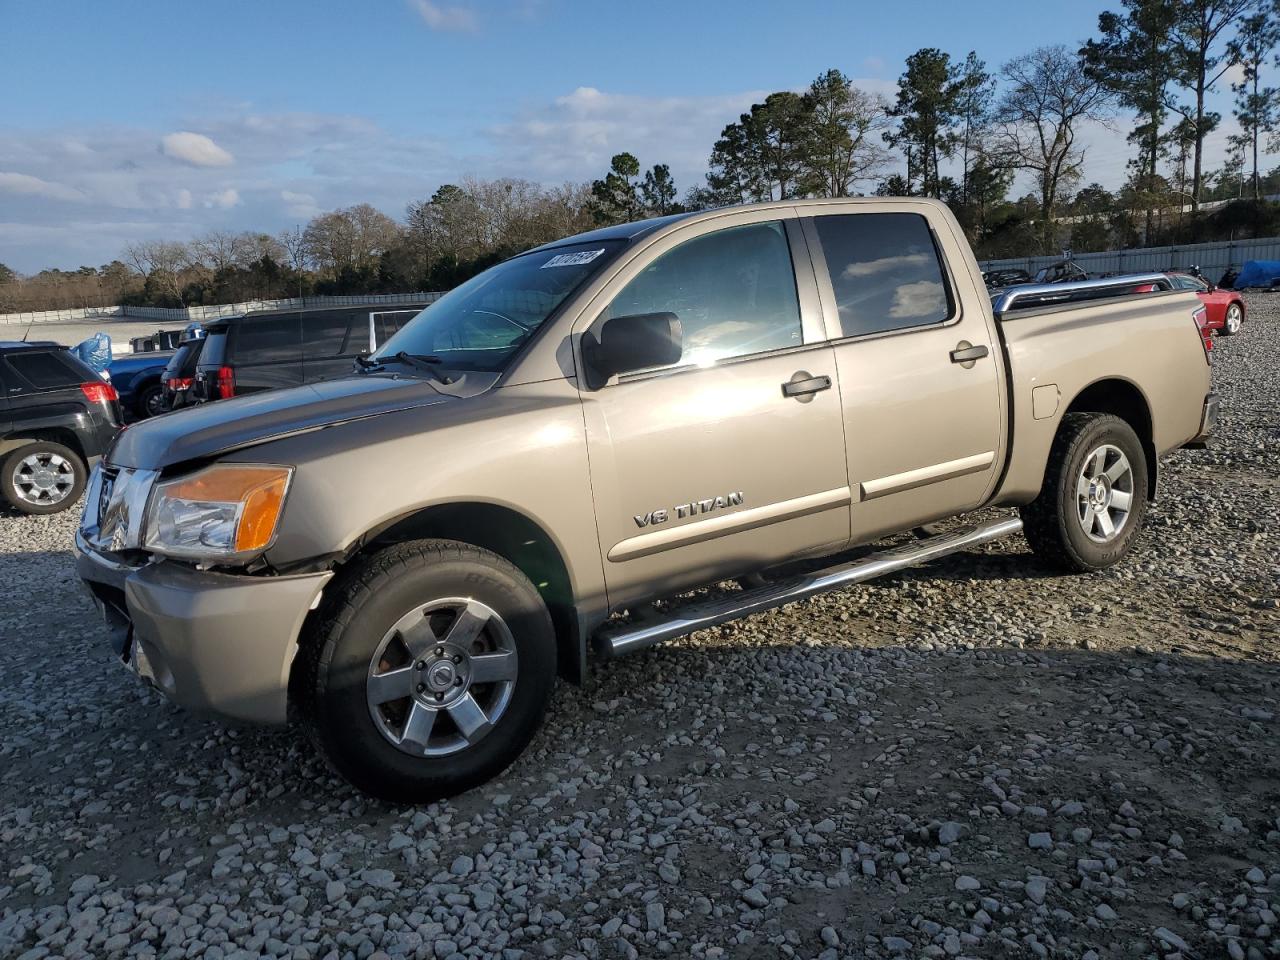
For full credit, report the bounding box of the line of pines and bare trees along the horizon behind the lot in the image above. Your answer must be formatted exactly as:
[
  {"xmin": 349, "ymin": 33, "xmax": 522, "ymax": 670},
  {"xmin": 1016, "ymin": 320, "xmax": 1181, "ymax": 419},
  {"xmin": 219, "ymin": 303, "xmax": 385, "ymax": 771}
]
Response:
[{"xmin": 0, "ymin": 0, "xmax": 1280, "ymax": 310}]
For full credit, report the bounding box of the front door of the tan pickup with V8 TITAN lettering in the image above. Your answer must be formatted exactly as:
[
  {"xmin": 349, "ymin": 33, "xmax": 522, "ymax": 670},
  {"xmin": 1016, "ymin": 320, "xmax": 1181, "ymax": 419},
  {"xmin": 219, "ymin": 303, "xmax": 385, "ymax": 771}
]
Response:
[{"xmin": 577, "ymin": 210, "xmax": 850, "ymax": 608}]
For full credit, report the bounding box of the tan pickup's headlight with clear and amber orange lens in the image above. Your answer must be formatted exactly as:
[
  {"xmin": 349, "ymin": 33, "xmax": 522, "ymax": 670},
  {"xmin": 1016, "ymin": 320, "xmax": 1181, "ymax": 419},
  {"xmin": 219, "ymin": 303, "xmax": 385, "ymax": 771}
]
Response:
[{"xmin": 146, "ymin": 463, "xmax": 293, "ymax": 561}]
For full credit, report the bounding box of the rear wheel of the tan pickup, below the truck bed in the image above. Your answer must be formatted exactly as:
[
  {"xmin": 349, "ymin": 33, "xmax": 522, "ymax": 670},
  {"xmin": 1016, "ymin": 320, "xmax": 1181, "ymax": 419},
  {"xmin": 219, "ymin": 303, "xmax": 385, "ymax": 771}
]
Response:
[{"xmin": 1021, "ymin": 413, "xmax": 1147, "ymax": 572}]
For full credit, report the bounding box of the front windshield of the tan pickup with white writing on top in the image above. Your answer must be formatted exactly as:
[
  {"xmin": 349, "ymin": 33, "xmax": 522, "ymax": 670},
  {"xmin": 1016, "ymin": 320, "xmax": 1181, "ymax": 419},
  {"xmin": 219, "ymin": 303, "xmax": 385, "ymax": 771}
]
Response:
[{"xmin": 374, "ymin": 241, "xmax": 621, "ymax": 372}]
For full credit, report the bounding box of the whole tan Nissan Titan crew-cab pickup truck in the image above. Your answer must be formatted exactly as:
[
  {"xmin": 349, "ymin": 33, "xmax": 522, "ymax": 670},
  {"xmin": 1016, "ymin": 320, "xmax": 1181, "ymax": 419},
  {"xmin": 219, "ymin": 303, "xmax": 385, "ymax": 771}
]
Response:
[{"xmin": 77, "ymin": 200, "xmax": 1216, "ymax": 800}]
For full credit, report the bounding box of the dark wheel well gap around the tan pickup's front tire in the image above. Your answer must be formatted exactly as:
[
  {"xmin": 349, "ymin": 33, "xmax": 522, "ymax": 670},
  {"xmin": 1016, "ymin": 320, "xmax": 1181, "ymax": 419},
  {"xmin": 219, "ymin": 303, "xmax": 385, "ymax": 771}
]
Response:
[{"xmin": 339, "ymin": 500, "xmax": 586, "ymax": 684}]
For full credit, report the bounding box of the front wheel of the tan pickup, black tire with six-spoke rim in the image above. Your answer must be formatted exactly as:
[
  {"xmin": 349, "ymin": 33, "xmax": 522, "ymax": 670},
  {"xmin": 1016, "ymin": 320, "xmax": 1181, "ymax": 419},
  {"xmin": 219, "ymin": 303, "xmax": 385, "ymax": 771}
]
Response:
[{"xmin": 302, "ymin": 540, "xmax": 556, "ymax": 803}]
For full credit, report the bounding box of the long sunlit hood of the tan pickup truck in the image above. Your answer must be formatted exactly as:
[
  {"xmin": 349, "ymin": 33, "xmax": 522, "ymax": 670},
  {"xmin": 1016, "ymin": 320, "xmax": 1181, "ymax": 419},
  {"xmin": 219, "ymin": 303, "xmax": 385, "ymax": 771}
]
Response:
[{"xmin": 106, "ymin": 374, "xmax": 452, "ymax": 470}]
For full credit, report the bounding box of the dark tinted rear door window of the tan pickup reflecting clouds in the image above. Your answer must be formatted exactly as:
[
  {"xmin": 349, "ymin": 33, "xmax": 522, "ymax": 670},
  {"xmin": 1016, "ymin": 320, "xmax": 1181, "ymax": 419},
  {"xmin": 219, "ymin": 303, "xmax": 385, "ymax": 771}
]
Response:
[{"xmin": 813, "ymin": 214, "xmax": 954, "ymax": 337}]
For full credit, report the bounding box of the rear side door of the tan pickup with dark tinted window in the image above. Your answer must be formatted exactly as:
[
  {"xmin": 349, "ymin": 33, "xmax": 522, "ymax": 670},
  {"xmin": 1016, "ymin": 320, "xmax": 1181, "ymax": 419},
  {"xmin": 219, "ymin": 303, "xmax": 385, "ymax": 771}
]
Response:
[{"xmin": 804, "ymin": 204, "xmax": 1005, "ymax": 543}]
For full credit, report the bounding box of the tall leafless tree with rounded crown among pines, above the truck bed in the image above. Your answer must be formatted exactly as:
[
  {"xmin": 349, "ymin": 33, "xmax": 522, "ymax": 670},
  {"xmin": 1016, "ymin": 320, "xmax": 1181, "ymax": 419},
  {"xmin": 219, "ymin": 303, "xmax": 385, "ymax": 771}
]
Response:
[{"xmin": 993, "ymin": 45, "xmax": 1111, "ymax": 250}]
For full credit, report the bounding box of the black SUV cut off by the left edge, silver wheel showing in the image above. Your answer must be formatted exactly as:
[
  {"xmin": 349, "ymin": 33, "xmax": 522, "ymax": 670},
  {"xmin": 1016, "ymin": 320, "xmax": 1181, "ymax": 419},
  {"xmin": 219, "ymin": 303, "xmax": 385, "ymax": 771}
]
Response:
[{"xmin": 0, "ymin": 340, "xmax": 120, "ymax": 513}]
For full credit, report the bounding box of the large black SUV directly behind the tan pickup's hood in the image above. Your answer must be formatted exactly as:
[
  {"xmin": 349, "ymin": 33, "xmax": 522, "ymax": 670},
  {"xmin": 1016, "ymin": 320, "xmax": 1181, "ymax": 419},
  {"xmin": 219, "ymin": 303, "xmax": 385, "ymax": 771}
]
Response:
[{"xmin": 192, "ymin": 303, "xmax": 426, "ymax": 403}]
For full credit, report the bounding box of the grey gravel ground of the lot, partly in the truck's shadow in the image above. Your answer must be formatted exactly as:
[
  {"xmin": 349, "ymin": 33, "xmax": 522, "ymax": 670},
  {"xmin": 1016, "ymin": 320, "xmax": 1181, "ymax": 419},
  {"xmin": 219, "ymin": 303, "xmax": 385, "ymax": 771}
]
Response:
[{"xmin": 0, "ymin": 294, "xmax": 1280, "ymax": 960}]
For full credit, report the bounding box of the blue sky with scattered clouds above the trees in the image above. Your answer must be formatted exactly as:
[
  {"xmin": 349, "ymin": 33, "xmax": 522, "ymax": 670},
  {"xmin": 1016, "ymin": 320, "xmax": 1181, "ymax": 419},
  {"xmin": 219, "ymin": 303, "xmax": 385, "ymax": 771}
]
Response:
[{"xmin": 0, "ymin": 0, "xmax": 1259, "ymax": 273}]
